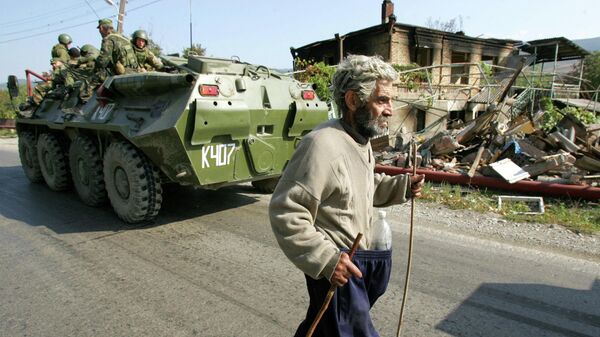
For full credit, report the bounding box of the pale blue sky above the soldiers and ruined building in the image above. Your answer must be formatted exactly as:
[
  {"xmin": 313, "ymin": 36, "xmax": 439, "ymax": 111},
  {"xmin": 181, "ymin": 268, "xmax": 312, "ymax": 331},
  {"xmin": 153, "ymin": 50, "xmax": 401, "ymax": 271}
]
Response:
[{"xmin": 0, "ymin": 0, "xmax": 600, "ymax": 78}]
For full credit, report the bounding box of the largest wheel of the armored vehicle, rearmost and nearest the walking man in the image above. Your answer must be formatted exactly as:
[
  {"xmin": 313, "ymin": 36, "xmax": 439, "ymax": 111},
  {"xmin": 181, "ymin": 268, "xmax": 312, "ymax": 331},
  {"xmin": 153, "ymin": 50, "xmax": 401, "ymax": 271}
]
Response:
[{"xmin": 104, "ymin": 142, "xmax": 162, "ymax": 223}]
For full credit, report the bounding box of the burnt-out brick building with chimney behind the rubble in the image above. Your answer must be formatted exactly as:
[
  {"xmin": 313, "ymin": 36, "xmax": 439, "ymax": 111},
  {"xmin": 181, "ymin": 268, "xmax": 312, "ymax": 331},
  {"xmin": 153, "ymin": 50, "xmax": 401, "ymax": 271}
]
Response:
[{"xmin": 291, "ymin": 0, "xmax": 519, "ymax": 141}]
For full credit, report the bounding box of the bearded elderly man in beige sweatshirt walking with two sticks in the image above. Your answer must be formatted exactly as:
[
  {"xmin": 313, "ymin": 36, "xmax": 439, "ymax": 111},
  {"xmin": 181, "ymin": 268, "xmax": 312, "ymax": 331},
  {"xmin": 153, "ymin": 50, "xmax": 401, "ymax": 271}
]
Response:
[{"xmin": 269, "ymin": 55, "xmax": 424, "ymax": 337}]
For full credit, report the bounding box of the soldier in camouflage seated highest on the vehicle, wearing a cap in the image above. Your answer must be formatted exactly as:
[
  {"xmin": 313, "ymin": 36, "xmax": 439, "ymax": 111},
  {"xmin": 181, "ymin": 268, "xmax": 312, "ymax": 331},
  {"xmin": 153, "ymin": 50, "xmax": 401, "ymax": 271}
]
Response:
[{"xmin": 96, "ymin": 19, "xmax": 140, "ymax": 81}]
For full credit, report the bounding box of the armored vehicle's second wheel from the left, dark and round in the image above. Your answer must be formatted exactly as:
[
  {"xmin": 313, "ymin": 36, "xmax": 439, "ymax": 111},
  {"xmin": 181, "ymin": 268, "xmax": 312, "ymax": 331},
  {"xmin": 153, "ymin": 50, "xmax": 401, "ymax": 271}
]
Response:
[{"xmin": 37, "ymin": 133, "xmax": 71, "ymax": 191}]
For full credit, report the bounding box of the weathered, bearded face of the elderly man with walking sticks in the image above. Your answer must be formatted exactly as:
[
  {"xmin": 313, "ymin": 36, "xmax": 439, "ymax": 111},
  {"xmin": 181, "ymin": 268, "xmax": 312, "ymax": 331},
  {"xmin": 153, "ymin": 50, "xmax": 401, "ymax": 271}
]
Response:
[{"xmin": 355, "ymin": 80, "xmax": 393, "ymax": 137}]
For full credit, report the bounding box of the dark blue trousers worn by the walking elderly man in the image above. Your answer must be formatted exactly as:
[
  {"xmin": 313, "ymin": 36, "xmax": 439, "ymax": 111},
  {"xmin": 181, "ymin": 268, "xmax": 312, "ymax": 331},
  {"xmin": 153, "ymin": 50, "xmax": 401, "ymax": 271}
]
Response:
[{"xmin": 294, "ymin": 250, "xmax": 392, "ymax": 337}]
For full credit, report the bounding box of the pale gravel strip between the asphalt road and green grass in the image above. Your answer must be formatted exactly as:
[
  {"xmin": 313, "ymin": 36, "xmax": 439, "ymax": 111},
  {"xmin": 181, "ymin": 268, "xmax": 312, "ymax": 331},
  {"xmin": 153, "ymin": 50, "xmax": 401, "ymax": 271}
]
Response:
[{"xmin": 388, "ymin": 201, "xmax": 600, "ymax": 262}]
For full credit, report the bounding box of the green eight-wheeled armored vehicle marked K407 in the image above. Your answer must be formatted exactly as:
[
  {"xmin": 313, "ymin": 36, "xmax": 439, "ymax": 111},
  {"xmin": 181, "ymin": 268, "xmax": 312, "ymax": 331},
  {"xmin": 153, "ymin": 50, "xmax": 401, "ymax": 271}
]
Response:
[{"xmin": 9, "ymin": 56, "xmax": 328, "ymax": 223}]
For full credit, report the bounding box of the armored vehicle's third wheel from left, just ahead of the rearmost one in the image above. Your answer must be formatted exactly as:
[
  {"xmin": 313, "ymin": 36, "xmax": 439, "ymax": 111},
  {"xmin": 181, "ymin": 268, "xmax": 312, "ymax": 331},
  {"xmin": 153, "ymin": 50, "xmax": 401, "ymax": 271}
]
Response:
[{"xmin": 69, "ymin": 137, "xmax": 107, "ymax": 206}]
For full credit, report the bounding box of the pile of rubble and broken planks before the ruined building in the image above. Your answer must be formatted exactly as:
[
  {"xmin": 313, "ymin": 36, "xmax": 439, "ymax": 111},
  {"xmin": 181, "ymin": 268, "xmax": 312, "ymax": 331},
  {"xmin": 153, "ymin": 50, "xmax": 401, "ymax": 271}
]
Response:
[{"xmin": 374, "ymin": 105, "xmax": 600, "ymax": 187}]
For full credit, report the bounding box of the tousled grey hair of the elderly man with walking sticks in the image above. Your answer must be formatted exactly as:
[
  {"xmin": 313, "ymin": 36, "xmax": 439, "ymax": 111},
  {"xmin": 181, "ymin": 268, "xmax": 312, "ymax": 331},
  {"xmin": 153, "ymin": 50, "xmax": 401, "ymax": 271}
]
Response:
[{"xmin": 330, "ymin": 55, "xmax": 398, "ymax": 114}]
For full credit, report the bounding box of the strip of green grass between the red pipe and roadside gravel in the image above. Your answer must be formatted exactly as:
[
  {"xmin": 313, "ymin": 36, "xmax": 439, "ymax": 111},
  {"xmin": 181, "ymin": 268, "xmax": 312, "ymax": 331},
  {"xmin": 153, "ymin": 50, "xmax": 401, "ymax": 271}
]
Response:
[{"xmin": 421, "ymin": 182, "xmax": 600, "ymax": 234}]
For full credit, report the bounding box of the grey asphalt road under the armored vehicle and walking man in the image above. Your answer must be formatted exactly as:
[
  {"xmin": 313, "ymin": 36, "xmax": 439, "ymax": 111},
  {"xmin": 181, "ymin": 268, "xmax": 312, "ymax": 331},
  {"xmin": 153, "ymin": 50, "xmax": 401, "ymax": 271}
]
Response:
[{"xmin": 0, "ymin": 139, "xmax": 600, "ymax": 337}]
